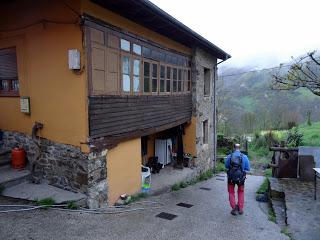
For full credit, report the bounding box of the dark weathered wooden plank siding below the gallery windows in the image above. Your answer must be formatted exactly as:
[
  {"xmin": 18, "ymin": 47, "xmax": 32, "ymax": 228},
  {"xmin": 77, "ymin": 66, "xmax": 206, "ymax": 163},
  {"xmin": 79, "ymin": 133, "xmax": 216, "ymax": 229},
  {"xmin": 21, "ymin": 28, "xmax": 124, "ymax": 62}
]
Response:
[{"xmin": 89, "ymin": 94, "xmax": 192, "ymax": 147}]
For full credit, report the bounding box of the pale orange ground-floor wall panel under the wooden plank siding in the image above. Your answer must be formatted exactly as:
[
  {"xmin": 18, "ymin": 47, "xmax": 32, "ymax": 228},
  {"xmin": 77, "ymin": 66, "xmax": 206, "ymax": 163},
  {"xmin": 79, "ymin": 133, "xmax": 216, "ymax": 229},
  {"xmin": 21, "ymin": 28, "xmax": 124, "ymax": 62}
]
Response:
[{"xmin": 107, "ymin": 138, "xmax": 141, "ymax": 205}]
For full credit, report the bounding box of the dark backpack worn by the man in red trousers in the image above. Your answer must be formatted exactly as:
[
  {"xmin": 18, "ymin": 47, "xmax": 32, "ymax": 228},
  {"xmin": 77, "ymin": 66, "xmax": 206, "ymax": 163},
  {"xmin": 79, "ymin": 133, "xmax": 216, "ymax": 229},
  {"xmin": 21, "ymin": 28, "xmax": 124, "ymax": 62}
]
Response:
[{"xmin": 227, "ymin": 153, "xmax": 246, "ymax": 185}]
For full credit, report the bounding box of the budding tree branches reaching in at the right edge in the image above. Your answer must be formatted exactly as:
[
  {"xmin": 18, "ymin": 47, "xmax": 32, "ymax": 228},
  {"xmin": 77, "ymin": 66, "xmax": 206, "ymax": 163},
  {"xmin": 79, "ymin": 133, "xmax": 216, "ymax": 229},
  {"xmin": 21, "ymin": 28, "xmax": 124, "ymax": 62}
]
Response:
[{"xmin": 272, "ymin": 51, "xmax": 320, "ymax": 96}]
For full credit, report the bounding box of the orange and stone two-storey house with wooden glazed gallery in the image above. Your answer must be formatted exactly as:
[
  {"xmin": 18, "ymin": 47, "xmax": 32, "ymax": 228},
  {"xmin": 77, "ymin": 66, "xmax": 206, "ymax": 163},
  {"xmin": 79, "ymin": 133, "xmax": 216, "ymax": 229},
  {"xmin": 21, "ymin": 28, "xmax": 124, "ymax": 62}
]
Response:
[{"xmin": 0, "ymin": 0, "xmax": 230, "ymax": 207}]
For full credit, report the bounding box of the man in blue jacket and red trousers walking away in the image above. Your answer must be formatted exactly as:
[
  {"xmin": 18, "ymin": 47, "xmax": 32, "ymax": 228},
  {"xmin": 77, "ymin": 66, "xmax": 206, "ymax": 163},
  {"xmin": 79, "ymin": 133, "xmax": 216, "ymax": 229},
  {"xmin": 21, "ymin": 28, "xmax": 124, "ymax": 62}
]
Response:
[{"xmin": 225, "ymin": 143, "xmax": 250, "ymax": 215}]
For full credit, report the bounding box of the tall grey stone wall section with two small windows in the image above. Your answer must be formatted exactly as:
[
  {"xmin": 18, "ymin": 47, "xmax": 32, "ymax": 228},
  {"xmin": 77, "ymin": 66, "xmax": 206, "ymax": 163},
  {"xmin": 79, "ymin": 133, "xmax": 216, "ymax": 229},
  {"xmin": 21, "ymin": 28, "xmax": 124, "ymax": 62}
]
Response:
[{"xmin": 192, "ymin": 48, "xmax": 217, "ymax": 171}]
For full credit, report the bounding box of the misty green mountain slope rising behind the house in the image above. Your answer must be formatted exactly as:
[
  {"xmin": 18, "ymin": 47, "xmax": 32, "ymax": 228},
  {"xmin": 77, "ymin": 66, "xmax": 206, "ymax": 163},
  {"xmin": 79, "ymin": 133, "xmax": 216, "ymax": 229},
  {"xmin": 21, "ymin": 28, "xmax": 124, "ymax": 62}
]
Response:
[{"xmin": 217, "ymin": 67, "xmax": 320, "ymax": 134}]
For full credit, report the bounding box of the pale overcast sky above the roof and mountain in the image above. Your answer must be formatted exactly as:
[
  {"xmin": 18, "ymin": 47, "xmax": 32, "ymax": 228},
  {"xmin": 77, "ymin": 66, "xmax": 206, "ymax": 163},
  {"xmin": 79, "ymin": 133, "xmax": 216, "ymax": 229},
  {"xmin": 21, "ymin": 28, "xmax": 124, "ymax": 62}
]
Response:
[{"xmin": 151, "ymin": 0, "xmax": 320, "ymax": 68}]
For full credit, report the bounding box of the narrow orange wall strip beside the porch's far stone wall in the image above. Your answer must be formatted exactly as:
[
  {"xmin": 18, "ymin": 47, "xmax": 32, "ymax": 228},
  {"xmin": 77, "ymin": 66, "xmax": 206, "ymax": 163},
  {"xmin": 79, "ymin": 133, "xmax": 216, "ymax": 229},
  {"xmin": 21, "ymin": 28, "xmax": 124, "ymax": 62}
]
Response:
[{"xmin": 183, "ymin": 117, "xmax": 197, "ymax": 156}]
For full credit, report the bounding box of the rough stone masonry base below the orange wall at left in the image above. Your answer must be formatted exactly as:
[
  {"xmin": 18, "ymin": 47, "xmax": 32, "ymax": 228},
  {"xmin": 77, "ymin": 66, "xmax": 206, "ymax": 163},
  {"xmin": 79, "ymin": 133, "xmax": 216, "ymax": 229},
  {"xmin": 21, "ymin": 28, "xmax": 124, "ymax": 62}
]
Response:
[{"xmin": 0, "ymin": 131, "xmax": 108, "ymax": 208}]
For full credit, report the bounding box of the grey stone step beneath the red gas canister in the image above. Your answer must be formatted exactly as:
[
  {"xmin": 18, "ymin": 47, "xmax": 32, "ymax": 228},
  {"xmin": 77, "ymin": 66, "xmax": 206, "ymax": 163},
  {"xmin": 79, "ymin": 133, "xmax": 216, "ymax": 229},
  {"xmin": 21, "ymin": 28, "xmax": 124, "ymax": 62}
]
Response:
[{"xmin": 0, "ymin": 165, "xmax": 30, "ymax": 188}]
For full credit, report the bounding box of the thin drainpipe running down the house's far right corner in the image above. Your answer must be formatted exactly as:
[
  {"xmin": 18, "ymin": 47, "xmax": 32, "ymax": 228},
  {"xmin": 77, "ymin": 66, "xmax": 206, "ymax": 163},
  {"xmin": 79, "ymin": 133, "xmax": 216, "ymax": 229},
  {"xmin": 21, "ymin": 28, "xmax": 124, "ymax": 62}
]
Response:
[{"xmin": 213, "ymin": 56, "xmax": 230, "ymax": 171}]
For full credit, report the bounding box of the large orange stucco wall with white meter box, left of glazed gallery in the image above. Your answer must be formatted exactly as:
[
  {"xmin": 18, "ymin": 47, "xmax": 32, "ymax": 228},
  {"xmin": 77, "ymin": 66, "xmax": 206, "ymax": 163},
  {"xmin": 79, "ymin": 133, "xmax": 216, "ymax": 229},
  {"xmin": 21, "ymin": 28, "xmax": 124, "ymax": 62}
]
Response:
[{"xmin": 0, "ymin": 0, "xmax": 88, "ymax": 146}]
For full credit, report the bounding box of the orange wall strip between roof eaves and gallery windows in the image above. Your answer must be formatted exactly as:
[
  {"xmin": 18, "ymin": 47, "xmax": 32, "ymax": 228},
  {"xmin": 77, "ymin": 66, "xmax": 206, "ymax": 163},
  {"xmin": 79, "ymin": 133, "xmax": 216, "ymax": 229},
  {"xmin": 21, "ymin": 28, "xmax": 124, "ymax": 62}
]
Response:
[{"xmin": 81, "ymin": 0, "xmax": 192, "ymax": 55}]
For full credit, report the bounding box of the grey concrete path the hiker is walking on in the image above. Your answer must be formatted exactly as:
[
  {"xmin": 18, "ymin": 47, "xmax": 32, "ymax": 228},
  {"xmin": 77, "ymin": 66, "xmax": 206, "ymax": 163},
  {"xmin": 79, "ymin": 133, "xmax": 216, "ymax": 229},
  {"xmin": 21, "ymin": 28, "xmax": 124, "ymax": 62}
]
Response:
[{"xmin": 0, "ymin": 176, "xmax": 288, "ymax": 240}]
